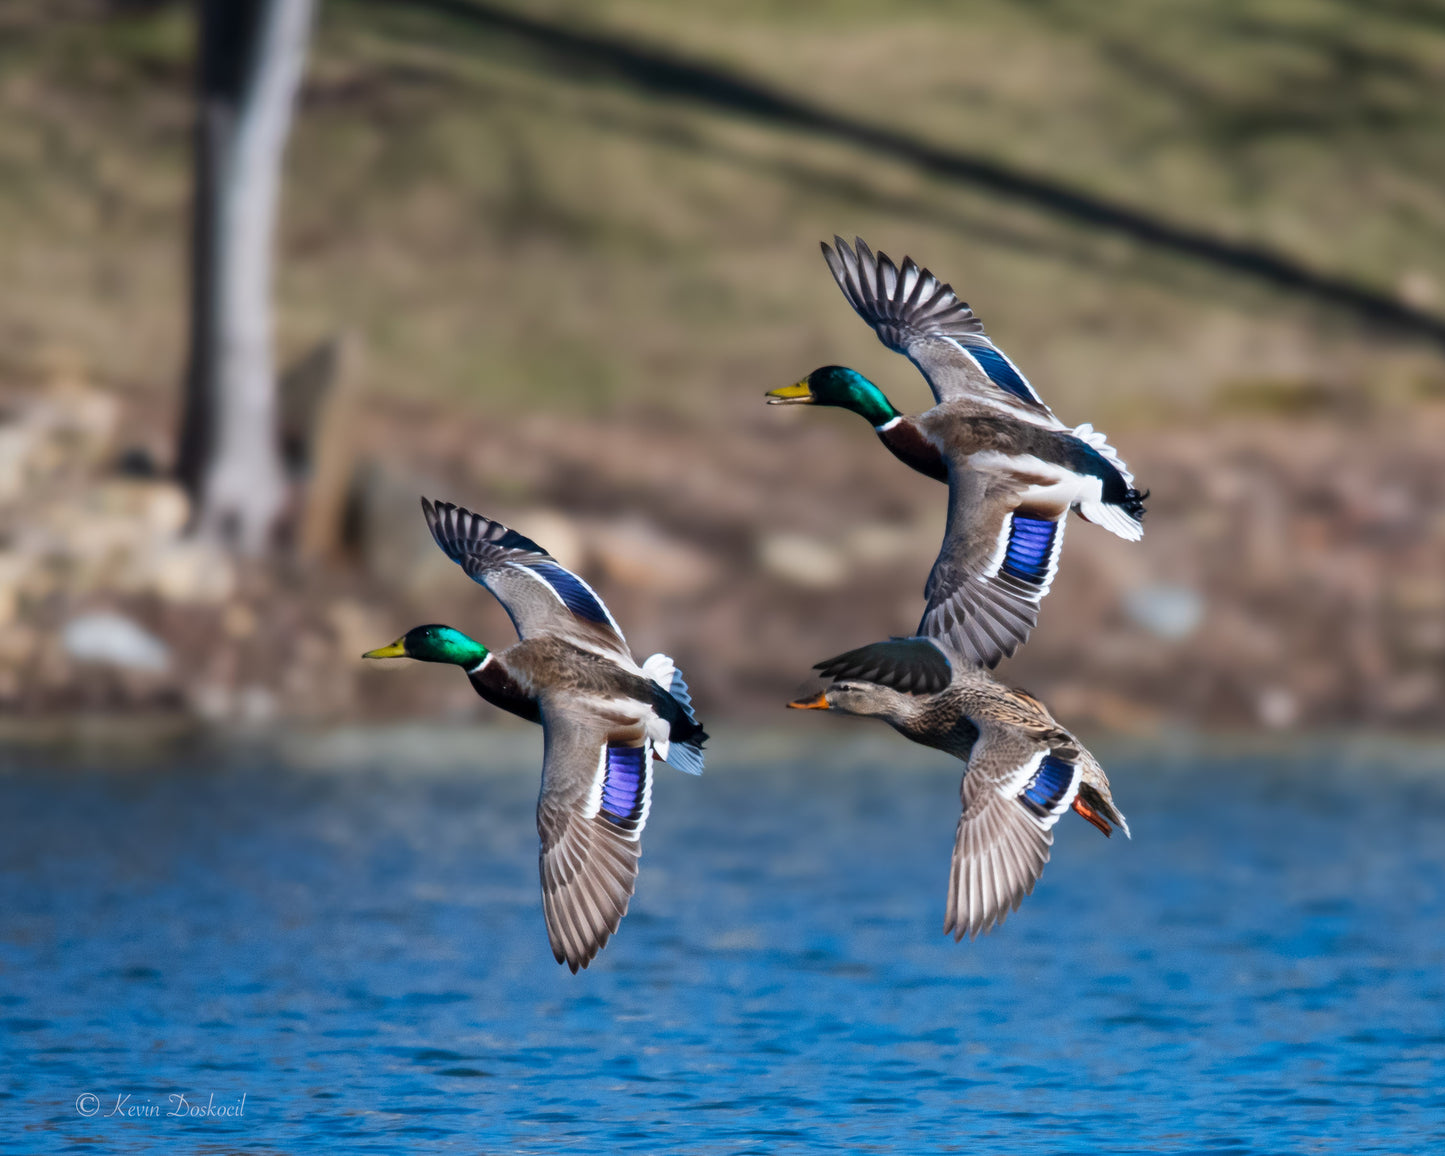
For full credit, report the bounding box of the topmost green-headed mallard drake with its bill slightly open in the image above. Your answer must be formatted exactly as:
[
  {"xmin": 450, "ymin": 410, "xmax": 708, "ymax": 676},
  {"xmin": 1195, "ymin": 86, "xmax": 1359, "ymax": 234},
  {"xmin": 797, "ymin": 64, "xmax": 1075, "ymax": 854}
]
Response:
[{"xmin": 767, "ymin": 237, "xmax": 1147, "ymax": 666}]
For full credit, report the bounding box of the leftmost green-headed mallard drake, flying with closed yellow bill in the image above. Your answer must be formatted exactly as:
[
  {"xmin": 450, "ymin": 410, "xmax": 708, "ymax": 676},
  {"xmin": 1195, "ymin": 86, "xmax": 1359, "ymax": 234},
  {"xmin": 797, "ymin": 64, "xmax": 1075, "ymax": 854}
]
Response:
[{"xmin": 363, "ymin": 499, "xmax": 707, "ymax": 972}]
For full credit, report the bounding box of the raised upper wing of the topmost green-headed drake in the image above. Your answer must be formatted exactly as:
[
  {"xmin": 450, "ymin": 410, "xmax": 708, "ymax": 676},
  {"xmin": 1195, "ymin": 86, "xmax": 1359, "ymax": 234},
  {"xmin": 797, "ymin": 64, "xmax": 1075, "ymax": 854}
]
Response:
[{"xmin": 822, "ymin": 237, "xmax": 1061, "ymax": 428}]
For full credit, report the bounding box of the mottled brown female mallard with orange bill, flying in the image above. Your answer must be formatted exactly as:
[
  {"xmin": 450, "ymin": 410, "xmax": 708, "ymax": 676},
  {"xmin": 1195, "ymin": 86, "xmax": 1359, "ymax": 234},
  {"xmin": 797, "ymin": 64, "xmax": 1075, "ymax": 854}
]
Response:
[{"xmin": 788, "ymin": 637, "xmax": 1129, "ymax": 939}]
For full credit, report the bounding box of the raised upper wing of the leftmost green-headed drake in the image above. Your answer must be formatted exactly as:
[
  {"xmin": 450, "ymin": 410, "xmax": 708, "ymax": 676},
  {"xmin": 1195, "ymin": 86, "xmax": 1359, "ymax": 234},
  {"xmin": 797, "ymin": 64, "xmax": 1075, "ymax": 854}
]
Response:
[{"xmin": 422, "ymin": 497, "xmax": 634, "ymax": 658}]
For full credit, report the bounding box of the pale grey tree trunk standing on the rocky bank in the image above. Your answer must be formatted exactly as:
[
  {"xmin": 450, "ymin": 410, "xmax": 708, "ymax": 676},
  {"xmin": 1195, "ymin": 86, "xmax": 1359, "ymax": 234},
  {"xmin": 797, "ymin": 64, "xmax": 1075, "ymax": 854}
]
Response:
[{"xmin": 192, "ymin": 0, "xmax": 315, "ymax": 553}]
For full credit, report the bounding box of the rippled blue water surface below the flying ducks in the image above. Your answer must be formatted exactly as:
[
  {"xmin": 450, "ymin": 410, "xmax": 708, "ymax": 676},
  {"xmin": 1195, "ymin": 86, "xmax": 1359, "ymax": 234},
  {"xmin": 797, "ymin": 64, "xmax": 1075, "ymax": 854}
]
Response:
[{"xmin": 0, "ymin": 720, "xmax": 1445, "ymax": 1153}]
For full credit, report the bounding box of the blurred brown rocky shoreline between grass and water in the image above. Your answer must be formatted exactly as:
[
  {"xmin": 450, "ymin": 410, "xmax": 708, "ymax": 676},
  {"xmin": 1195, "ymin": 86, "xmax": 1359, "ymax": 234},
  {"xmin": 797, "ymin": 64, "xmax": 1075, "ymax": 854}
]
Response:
[{"xmin": 0, "ymin": 387, "xmax": 1445, "ymax": 731}]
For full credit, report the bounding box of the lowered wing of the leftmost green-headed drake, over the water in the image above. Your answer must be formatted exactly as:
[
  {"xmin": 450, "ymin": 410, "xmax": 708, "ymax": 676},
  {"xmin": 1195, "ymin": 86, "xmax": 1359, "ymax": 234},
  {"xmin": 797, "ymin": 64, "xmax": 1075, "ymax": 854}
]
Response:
[{"xmin": 538, "ymin": 699, "xmax": 653, "ymax": 972}]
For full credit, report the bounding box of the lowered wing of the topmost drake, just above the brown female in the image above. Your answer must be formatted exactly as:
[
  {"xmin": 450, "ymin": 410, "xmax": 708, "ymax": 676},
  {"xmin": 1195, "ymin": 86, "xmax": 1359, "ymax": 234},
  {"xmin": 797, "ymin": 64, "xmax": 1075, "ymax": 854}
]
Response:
[{"xmin": 918, "ymin": 465, "xmax": 1068, "ymax": 668}]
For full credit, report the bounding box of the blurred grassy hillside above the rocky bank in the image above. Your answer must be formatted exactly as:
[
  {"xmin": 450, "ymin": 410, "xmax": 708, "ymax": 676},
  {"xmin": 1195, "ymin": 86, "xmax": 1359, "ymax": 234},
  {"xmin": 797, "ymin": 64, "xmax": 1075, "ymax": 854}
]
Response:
[{"xmin": 8, "ymin": 0, "xmax": 1445, "ymax": 427}]
